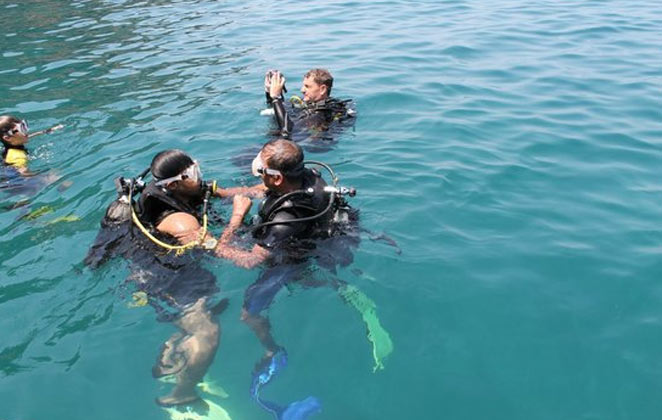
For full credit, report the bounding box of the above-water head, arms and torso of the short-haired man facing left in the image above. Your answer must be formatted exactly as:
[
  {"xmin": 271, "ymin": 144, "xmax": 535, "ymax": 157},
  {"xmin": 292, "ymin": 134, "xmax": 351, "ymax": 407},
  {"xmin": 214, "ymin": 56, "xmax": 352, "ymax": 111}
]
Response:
[{"xmin": 215, "ymin": 139, "xmax": 356, "ymax": 268}]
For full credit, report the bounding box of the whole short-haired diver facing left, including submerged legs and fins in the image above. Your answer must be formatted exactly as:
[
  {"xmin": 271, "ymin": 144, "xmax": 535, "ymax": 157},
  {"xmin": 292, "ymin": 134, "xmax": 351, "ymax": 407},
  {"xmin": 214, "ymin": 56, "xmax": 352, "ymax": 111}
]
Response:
[{"xmin": 215, "ymin": 139, "xmax": 390, "ymax": 420}]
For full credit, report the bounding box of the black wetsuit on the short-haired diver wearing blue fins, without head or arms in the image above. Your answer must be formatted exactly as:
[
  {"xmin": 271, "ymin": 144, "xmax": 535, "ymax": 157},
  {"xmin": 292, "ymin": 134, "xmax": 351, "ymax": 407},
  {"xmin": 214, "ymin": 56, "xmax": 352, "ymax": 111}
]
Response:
[{"xmin": 244, "ymin": 169, "xmax": 358, "ymax": 315}]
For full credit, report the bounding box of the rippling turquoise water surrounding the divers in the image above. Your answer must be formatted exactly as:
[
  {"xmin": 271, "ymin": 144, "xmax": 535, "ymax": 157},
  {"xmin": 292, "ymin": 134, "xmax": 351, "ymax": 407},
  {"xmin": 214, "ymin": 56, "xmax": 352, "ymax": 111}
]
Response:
[{"xmin": 0, "ymin": 0, "xmax": 662, "ymax": 420}]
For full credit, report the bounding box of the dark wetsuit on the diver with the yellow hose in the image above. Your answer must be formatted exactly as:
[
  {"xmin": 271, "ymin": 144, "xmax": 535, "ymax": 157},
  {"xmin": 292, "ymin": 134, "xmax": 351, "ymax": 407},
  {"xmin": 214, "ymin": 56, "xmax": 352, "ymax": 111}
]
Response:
[{"xmin": 85, "ymin": 183, "xmax": 219, "ymax": 321}]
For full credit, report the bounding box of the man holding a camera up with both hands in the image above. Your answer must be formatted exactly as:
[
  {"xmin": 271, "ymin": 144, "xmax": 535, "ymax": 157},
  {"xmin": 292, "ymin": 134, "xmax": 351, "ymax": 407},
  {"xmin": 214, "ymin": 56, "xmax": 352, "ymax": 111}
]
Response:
[{"xmin": 264, "ymin": 69, "xmax": 356, "ymax": 152}]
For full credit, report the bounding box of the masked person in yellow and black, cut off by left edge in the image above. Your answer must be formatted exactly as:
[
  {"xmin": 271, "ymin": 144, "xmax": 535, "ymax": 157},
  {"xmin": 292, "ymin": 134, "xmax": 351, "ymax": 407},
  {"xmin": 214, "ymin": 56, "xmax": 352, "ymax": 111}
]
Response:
[{"xmin": 0, "ymin": 115, "xmax": 65, "ymax": 203}]
